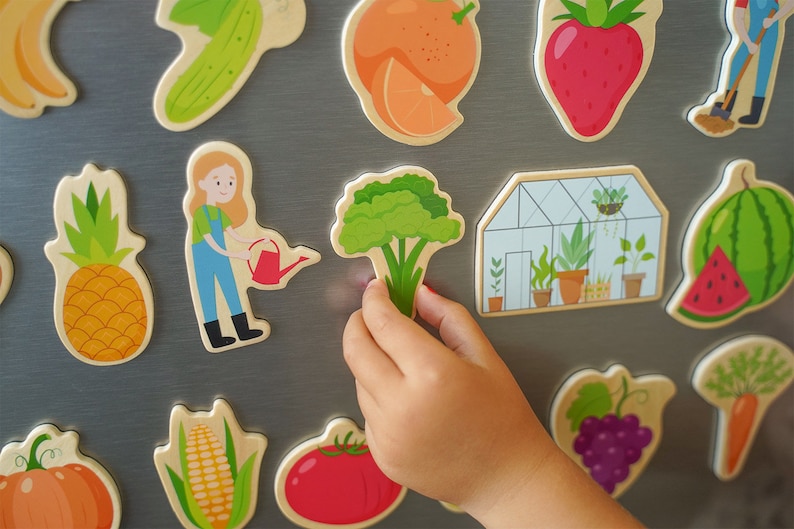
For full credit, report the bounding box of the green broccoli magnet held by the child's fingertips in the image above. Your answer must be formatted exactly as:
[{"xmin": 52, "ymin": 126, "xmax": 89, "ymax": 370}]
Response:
[{"xmin": 331, "ymin": 165, "xmax": 464, "ymax": 317}]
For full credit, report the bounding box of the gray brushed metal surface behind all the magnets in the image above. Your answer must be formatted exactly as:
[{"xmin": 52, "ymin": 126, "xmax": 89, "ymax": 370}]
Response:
[{"xmin": 0, "ymin": 0, "xmax": 794, "ymax": 528}]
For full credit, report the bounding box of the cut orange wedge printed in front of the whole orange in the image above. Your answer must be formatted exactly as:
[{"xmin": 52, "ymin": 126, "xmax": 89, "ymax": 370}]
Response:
[{"xmin": 372, "ymin": 58, "xmax": 459, "ymax": 137}]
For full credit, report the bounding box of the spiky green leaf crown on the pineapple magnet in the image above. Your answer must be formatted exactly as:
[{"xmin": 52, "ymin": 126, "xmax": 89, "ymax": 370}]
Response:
[{"xmin": 63, "ymin": 182, "xmax": 132, "ymax": 267}]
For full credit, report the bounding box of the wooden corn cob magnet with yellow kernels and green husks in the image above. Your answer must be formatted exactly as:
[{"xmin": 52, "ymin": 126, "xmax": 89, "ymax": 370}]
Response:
[{"xmin": 154, "ymin": 399, "xmax": 267, "ymax": 529}]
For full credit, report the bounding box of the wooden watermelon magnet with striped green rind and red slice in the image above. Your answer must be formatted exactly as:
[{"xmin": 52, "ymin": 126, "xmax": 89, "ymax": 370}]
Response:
[{"xmin": 666, "ymin": 160, "xmax": 794, "ymax": 329}]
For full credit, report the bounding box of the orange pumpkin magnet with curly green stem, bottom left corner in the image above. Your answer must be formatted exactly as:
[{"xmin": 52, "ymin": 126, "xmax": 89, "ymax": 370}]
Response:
[{"xmin": 0, "ymin": 424, "xmax": 121, "ymax": 529}]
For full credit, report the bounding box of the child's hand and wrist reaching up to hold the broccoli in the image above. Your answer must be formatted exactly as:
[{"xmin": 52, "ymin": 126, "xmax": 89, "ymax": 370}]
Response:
[{"xmin": 343, "ymin": 280, "xmax": 634, "ymax": 527}]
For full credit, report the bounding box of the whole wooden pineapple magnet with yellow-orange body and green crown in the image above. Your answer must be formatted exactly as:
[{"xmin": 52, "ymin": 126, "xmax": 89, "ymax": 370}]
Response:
[{"xmin": 44, "ymin": 164, "xmax": 154, "ymax": 365}]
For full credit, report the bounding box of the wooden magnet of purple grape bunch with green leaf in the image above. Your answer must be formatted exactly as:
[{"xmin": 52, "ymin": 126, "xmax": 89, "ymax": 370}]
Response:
[{"xmin": 551, "ymin": 364, "xmax": 675, "ymax": 498}]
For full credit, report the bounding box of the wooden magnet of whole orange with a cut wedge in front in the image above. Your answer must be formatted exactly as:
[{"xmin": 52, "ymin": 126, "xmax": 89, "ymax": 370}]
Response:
[{"xmin": 342, "ymin": 0, "xmax": 481, "ymax": 145}]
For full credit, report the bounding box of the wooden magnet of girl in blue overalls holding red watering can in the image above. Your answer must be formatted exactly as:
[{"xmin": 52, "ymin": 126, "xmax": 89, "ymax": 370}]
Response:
[{"xmin": 183, "ymin": 141, "xmax": 320, "ymax": 353}]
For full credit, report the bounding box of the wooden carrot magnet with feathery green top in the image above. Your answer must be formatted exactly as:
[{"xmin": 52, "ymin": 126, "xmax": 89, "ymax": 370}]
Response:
[{"xmin": 692, "ymin": 335, "xmax": 794, "ymax": 481}]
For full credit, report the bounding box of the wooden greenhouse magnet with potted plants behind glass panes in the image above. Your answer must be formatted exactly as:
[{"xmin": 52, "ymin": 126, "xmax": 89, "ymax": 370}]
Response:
[{"xmin": 475, "ymin": 165, "xmax": 668, "ymax": 316}]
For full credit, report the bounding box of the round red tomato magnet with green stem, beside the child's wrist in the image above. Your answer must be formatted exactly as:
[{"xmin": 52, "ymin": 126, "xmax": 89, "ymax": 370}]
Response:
[{"xmin": 276, "ymin": 417, "xmax": 408, "ymax": 529}]
